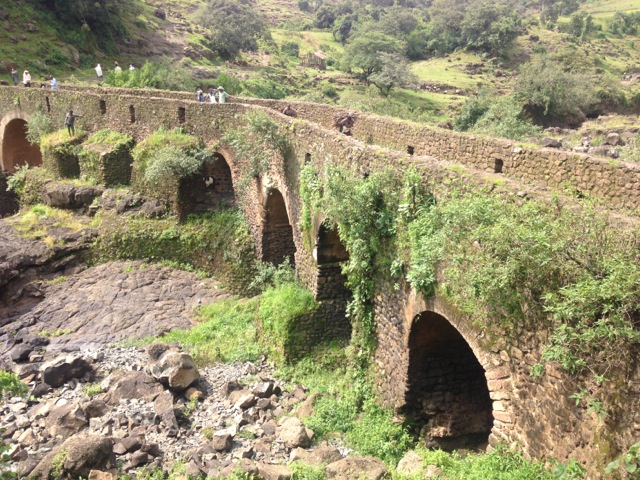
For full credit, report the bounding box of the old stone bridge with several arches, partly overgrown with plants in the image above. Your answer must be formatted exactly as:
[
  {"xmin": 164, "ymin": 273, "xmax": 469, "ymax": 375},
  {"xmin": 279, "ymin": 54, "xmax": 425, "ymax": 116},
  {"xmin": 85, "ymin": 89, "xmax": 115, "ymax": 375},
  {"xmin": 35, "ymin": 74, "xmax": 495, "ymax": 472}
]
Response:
[{"xmin": 0, "ymin": 87, "xmax": 640, "ymax": 476}]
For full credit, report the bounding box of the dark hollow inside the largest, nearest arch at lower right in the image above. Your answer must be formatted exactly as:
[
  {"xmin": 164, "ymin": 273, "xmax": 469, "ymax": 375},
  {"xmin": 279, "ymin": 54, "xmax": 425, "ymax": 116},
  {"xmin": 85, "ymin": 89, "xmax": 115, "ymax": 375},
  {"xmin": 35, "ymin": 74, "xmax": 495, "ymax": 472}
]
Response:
[{"xmin": 405, "ymin": 311, "xmax": 493, "ymax": 451}]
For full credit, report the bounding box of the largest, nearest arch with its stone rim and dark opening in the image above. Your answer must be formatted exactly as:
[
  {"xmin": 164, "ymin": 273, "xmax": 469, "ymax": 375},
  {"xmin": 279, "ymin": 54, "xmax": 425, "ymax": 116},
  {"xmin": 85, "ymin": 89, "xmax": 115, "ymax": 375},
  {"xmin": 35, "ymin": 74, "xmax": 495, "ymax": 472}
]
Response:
[{"xmin": 401, "ymin": 292, "xmax": 504, "ymax": 450}]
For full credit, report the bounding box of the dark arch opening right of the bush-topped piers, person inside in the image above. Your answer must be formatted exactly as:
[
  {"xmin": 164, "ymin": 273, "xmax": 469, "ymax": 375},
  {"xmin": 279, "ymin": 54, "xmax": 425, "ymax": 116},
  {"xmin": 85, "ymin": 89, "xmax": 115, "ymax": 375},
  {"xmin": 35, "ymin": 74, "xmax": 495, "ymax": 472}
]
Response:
[{"xmin": 180, "ymin": 153, "xmax": 236, "ymax": 217}]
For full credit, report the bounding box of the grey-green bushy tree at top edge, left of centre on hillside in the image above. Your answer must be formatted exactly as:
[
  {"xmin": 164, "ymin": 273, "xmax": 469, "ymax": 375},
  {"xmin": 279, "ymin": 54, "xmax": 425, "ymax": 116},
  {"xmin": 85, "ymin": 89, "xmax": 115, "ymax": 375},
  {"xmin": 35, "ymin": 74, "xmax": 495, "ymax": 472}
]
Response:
[{"xmin": 196, "ymin": 0, "xmax": 270, "ymax": 58}]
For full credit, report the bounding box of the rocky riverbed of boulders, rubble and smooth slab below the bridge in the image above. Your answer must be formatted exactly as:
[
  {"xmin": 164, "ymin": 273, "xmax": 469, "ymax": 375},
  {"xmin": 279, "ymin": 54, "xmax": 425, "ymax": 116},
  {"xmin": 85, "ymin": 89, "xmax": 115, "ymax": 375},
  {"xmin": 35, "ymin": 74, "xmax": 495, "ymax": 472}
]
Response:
[{"xmin": 0, "ymin": 220, "xmax": 402, "ymax": 480}]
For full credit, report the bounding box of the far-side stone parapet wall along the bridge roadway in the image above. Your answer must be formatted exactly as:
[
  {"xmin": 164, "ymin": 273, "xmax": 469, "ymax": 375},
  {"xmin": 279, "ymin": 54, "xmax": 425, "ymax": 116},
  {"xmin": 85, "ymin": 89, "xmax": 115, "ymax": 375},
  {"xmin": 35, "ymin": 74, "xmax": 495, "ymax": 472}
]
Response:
[{"xmin": 56, "ymin": 84, "xmax": 640, "ymax": 209}]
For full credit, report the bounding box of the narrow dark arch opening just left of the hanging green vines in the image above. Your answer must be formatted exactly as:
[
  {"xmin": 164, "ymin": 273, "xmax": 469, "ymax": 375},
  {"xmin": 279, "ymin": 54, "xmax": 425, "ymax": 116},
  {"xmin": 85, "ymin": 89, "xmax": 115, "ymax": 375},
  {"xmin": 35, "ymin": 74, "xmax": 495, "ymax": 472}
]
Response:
[{"xmin": 314, "ymin": 222, "xmax": 351, "ymax": 300}]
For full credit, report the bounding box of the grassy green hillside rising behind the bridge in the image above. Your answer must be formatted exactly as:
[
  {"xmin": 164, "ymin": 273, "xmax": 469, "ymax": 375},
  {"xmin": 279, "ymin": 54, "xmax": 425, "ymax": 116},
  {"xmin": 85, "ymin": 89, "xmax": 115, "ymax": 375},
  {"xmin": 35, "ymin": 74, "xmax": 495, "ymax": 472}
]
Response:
[{"xmin": 0, "ymin": 0, "xmax": 640, "ymax": 127}]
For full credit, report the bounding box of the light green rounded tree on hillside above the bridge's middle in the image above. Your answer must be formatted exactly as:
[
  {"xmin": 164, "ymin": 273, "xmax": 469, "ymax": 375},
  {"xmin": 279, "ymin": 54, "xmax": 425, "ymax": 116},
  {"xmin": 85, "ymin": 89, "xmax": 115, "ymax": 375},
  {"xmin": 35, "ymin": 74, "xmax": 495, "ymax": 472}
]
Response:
[{"xmin": 342, "ymin": 26, "xmax": 405, "ymax": 83}]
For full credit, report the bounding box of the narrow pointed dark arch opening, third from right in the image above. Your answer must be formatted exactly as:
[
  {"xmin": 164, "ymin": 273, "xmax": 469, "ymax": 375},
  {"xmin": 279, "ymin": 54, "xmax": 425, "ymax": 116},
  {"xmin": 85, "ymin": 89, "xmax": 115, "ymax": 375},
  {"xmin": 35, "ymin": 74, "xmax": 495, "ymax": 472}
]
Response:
[{"xmin": 262, "ymin": 189, "xmax": 296, "ymax": 265}]
